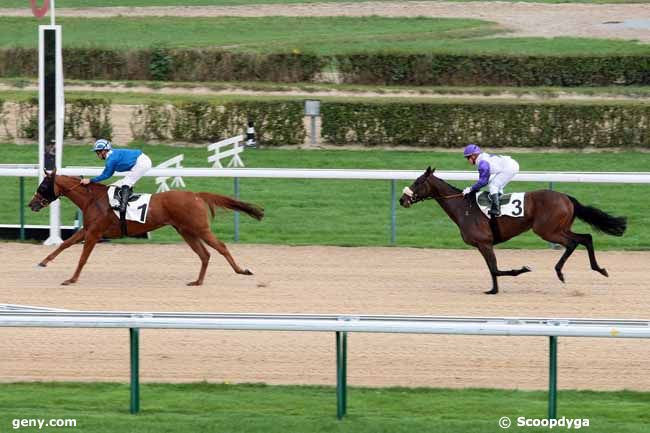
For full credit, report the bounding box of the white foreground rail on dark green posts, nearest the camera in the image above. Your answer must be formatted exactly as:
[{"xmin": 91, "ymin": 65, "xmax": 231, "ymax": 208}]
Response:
[{"xmin": 0, "ymin": 310, "xmax": 650, "ymax": 419}]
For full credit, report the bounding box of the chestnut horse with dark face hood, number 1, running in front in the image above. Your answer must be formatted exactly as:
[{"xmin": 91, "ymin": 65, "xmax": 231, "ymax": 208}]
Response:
[{"xmin": 29, "ymin": 170, "xmax": 264, "ymax": 286}]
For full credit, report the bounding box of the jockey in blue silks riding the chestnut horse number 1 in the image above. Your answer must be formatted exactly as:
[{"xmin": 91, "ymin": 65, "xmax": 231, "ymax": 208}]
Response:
[{"xmin": 81, "ymin": 138, "xmax": 151, "ymax": 219}]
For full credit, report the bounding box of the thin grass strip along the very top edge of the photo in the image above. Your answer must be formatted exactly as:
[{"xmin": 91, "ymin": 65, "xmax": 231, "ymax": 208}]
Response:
[{"xmin": 2, "ymin": 0, "xmax": 645, "ymax": 9}]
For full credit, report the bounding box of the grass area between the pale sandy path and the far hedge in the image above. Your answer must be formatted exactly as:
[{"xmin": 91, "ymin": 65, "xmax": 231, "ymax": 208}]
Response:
[{"xmin": 0, "ymin": 16, "xmax": 650, "ymax": 56}]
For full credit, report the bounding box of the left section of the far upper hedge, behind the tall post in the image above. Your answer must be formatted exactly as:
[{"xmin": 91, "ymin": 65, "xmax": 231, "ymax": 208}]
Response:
[{"xmin": 0, "ymin": 47, "xmax": 325, "ymax": 82}]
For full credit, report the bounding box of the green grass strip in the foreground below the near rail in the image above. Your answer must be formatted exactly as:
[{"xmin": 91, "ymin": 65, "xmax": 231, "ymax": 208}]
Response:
[{"xmin": 0, "ymin": 383, "xmax": 650, "ymax": 433}]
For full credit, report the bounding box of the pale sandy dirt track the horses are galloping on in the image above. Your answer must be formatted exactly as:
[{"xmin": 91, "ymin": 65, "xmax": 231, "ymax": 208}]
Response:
[{"xmin": 0, "ymin": 243, "xmax": 650, "ymax": 391}]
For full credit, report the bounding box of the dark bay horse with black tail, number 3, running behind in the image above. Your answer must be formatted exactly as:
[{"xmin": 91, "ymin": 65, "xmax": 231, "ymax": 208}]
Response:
[{"xmin": 399, "ymin": 167, "xmax": 627, "ymax": 295}]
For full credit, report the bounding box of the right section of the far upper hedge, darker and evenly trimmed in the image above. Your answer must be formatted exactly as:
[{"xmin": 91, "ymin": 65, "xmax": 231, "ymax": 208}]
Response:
[{"xmin": 336, "ymin": 53, "xmax": 650, "ymax": 86}]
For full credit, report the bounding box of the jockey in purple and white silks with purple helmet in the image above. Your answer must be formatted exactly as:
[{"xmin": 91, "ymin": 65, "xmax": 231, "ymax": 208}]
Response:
[{"xmin": 463, "ymin": 144, "xmax": 519, "ymax": 217}]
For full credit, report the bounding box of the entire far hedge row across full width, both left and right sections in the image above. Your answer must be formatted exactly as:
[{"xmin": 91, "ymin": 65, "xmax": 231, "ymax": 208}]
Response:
[{"xmin": 0, "ymin": 46, "xmax": 650, "ymax": 86}]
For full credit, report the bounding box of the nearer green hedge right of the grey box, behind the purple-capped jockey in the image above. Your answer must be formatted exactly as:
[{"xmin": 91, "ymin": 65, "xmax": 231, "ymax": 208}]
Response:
[{"xmin": 321, "ymin": 102, "xmax": 650, "ymax": 148}]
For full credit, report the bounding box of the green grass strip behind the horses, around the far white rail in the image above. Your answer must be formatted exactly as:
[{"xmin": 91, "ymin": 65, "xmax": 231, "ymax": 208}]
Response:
[{"xmin": 0, "ymin": 144, "xmax": 650, "ymax": 249}]
